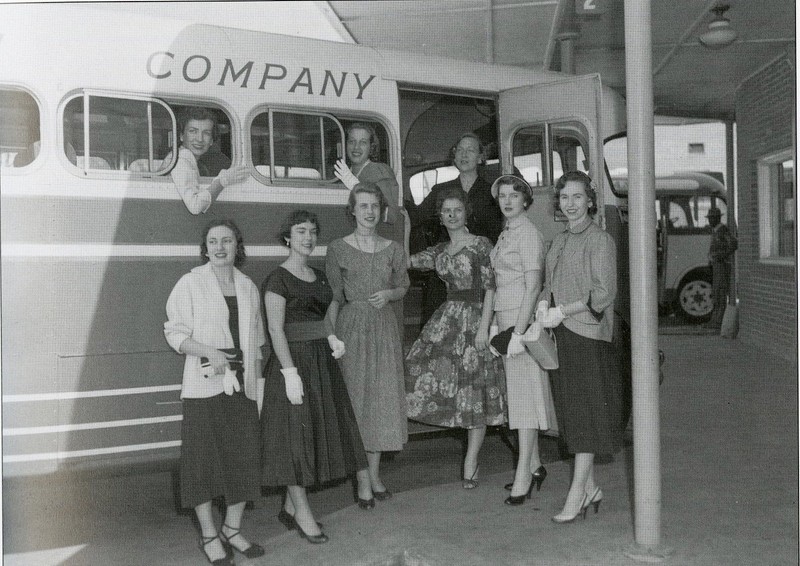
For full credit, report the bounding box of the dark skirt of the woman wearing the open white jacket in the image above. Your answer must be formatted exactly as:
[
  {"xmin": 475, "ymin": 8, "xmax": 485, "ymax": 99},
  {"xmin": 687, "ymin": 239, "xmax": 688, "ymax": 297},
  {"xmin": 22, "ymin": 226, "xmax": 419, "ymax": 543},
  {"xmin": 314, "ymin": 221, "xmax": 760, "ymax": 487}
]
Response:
[{"xmin": 180, "ymin": 393, "xmax": 261, "ymax": 508}]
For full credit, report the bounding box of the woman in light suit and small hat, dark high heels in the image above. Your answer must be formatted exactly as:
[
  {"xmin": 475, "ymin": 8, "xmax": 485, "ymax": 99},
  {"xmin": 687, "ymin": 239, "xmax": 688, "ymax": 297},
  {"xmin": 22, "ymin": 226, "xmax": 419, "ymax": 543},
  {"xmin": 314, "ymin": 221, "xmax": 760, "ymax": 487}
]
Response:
[{"xmin": 491, "ymin": 175, "xmax": 556, "ymax": 505}]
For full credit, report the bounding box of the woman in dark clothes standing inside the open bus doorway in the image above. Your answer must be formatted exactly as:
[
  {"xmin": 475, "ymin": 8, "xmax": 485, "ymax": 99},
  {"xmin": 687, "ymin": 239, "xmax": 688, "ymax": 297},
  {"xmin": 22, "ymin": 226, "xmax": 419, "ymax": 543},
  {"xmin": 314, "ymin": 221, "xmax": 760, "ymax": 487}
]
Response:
[{"xmin": 408, "ymin": 132, "xmax": 503, "ymax": 323}]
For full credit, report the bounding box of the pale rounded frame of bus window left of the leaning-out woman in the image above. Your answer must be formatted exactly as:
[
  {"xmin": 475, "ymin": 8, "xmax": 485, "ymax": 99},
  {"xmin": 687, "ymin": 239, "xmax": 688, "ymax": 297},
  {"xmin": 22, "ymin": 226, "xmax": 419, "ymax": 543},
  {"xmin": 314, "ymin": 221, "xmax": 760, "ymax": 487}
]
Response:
[{"xmin": 56, "ymin": 88, "xmax": 179, "ymax": 179}]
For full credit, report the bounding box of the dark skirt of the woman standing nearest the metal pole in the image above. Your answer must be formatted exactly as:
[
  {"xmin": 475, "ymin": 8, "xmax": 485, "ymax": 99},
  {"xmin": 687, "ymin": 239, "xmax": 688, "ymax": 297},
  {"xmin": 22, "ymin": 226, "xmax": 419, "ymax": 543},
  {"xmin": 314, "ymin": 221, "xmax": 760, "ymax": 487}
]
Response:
[{"xmin": 550, "ymin": 324, "xmax": 623, "ymax": 455}]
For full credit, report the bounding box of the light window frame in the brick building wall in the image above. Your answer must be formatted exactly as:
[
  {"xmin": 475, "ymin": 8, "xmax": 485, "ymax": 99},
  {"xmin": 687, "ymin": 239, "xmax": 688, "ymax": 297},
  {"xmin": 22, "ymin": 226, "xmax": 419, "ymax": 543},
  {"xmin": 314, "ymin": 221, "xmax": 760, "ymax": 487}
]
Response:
[{"xmin": 756, "ymin": 147, "xmax": 797, "ymax": 266}]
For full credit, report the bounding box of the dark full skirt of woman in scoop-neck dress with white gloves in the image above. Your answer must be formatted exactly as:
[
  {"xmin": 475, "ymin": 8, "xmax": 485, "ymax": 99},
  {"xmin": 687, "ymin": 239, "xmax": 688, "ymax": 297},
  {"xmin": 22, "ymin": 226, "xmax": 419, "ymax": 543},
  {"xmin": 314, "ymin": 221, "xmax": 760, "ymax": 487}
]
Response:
[{"xmin": 261, "ymin": 339, "xmax": 367, "ymax": 486}]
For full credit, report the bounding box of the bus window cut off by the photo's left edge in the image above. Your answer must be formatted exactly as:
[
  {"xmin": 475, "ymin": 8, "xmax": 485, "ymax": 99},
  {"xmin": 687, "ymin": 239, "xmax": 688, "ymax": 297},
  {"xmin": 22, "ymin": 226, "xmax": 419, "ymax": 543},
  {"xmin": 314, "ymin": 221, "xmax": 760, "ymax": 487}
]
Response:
[{"xmin": 0, "ymin": 88, "xmax": 41, "ymax": 168}]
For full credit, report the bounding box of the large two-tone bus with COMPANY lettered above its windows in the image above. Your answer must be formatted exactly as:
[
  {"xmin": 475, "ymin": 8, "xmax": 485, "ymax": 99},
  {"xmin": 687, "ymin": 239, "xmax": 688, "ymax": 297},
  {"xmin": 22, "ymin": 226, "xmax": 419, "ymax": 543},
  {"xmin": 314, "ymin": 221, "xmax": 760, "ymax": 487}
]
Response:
[{"xmin": 0, "ymin": 4, "xmax": 627, "ymax": 476}]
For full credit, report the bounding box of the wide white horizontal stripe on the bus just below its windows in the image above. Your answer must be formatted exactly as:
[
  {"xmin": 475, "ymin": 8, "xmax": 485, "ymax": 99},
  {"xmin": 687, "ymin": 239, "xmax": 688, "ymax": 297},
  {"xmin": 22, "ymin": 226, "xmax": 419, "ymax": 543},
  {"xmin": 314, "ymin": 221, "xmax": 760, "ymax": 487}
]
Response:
[{"xmin": 0, "ymin": 243, "xmax": 328, "ymax": 260}]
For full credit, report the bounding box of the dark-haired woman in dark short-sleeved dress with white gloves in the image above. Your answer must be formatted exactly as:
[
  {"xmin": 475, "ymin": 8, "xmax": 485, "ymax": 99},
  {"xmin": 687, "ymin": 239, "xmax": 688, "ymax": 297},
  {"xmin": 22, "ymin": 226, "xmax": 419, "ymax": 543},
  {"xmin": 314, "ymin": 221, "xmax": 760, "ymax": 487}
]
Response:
[{"xmin": 261, "ymin": 210, "xmax": 367, "ymax": 544}]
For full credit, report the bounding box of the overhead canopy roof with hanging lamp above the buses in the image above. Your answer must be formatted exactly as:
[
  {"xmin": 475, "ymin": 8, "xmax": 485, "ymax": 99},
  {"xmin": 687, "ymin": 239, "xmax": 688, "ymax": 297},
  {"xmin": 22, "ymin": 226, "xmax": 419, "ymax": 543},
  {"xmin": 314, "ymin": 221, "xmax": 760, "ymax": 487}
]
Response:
[{"xmin": 328, "ymin": 0, "xmax": 795, "ymax": 119}]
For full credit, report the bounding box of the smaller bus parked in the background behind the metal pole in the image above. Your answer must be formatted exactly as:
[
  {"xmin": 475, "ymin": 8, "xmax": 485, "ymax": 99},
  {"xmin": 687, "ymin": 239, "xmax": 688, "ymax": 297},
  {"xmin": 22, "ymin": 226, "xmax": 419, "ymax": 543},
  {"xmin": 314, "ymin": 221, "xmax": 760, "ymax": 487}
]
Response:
[{"xmin": 612, "ymin": 171, "xmax": 728, "ymax": 323}]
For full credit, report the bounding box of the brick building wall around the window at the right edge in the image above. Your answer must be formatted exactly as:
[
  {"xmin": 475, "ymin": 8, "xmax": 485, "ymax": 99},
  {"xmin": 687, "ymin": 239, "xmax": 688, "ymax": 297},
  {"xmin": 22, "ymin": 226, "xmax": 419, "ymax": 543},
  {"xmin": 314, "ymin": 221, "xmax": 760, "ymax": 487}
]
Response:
[{"xmin": 736, "ymin": 58, "xmax": 797, "ymax": 360}]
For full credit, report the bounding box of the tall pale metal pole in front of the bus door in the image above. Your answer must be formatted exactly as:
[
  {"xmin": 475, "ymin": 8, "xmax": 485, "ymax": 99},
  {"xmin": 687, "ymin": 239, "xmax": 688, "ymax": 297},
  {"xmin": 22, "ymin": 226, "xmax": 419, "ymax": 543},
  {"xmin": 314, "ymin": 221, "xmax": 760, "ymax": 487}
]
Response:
[{"xmin": 625, "ymin": 0, "xmax": 664, "ymax": 562}]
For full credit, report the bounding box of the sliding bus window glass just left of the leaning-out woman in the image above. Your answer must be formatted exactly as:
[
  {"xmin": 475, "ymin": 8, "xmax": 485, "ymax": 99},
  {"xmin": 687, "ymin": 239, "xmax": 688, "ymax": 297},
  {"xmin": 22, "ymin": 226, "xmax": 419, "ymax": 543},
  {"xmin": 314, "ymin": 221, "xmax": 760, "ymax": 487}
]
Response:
[{"xmin": 64, "ymin": 93, "xmax": 175, "ymax": 173}]
